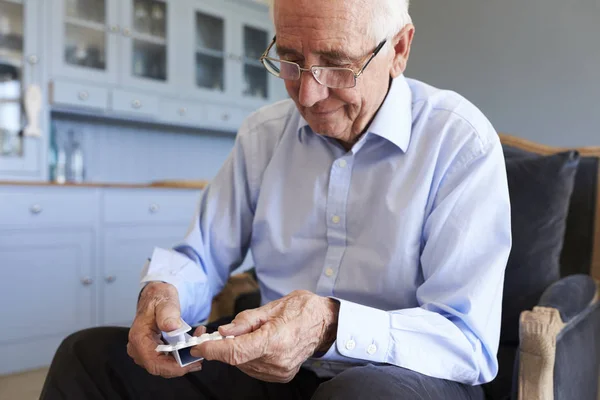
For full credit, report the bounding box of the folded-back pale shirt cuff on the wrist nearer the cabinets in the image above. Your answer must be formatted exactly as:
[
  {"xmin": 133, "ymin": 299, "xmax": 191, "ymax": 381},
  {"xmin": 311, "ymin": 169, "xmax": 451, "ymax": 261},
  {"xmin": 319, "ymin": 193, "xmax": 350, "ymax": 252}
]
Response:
[{"xmin": 140, "ymin": 247, "xmax": 207, "ymax": 322}]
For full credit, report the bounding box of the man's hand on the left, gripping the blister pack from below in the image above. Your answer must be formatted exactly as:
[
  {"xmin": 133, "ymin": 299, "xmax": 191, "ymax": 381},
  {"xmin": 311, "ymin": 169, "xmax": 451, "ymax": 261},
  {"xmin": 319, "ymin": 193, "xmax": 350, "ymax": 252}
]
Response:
[{"xmin": 127, "ymin": 282, "xmax": 204, "ymax": 378}]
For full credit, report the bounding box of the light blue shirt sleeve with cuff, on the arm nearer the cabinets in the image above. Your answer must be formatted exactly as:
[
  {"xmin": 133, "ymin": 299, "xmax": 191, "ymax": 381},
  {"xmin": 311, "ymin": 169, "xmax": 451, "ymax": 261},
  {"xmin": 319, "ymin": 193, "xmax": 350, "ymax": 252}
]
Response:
[{"xmin": 141, "ymin": 122, "xmax": 256, "ymax": 324}]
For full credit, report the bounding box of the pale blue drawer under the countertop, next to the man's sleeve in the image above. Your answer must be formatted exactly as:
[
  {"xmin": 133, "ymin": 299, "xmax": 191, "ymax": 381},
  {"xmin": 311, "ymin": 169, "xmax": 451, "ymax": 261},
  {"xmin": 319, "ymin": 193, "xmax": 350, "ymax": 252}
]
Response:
[{"xmin": 103, "ymin": 189, "xmax": 200, "ymax": 224}]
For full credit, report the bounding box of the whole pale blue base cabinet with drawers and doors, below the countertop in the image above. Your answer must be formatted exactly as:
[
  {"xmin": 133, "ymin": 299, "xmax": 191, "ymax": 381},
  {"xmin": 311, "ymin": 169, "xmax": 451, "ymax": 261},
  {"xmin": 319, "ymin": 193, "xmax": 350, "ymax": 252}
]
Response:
[{"xmin": 0, "ymin": 185, "xmax": 200, "ymax": 375}]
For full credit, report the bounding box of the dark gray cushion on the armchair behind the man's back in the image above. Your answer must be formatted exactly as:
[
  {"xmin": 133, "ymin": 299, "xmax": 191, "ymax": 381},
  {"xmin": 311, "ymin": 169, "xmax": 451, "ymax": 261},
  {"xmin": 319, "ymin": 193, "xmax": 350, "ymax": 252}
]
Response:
[{"xmin": 500, "ymin": 148, "xmax": 579, "ymax": 344}]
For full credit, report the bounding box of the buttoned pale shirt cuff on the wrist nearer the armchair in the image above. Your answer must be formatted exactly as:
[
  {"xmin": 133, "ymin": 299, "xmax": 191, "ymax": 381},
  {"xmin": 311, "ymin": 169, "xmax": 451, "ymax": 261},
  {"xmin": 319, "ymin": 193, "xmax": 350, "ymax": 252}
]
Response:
[{"xmin": 322, "ymin": 298, "xmax": 390, "ymax": 363}]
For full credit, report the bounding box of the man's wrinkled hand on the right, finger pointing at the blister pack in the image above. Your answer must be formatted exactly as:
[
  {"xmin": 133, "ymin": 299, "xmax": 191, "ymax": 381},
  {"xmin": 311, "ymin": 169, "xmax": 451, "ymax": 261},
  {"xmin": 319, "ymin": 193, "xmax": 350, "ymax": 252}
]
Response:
[{"xmin": 191, "ymin": 291, "xmax": 339, "ymax": 383}]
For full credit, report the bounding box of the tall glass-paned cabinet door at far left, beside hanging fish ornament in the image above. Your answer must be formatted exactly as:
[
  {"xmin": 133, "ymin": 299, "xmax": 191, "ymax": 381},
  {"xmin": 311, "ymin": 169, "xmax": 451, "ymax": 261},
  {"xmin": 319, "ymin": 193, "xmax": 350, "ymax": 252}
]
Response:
[{"xmin": 0, "ymin": 0, "xmax": 44, "ymax": 179}]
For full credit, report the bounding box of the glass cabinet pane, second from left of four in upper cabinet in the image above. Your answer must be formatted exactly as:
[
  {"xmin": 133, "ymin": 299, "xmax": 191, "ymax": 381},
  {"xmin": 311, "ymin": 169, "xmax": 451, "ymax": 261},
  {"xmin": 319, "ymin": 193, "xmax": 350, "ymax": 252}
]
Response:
[{"xmin": 132, "ymin": 0, "xmax": 168, "ymax": 81}]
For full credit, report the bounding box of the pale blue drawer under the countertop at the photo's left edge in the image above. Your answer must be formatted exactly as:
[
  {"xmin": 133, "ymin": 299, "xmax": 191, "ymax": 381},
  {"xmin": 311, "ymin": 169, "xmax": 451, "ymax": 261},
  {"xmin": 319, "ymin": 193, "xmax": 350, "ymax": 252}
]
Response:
[{"xmin": 0, "ymin": 186, "xmax": 98, "ymax": 228}]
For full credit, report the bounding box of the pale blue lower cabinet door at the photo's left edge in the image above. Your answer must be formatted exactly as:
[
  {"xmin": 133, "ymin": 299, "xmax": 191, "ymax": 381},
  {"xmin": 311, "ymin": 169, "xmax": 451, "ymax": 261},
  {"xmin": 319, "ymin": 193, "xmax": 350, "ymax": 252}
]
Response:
[{"xmin": 0, "ymin": 229, "xmax": 95, "ymax": 374}]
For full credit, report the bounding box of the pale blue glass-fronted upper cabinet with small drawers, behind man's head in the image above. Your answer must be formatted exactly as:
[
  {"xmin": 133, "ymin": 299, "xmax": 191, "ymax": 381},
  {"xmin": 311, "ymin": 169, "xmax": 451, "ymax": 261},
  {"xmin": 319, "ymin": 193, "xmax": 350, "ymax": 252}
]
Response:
[{"xmin": 50, "ymin": 0, "xmax": 285, "ymax": 132}]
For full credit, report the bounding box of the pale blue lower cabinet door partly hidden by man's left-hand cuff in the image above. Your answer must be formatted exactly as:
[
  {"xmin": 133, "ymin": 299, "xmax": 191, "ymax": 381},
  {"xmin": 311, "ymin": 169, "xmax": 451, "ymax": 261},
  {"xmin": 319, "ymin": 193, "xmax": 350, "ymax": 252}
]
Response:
[{"xmin": 99, "ymin": 223, "xmax": 187, "ymax": 326}]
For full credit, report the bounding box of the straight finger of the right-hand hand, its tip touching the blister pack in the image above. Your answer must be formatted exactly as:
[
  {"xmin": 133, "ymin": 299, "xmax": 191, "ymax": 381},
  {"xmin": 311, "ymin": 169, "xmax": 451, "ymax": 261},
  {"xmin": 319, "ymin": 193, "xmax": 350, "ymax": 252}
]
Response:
[{"xmin": 191, "ymin": 329, "xmax": 268, "ymax": 365}]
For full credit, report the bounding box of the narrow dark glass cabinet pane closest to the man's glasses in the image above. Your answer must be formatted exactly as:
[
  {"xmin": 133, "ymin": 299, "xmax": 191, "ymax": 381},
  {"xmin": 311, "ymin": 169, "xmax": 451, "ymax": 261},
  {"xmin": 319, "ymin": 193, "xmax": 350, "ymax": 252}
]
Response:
[{"xmin": 243, "ymin": 26, "xmax": 269, "ymax": 99}]
